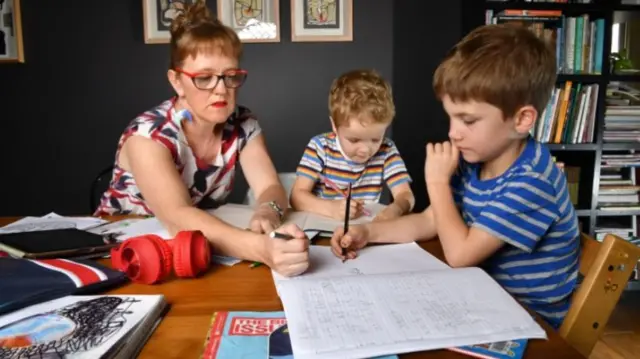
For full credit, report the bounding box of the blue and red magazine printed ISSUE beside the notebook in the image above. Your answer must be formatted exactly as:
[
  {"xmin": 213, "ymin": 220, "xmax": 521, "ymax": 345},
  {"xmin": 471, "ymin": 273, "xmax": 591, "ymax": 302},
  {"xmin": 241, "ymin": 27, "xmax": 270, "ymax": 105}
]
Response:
[{"xmin": 202, "ymin": 311, "xmax": 398, "ymax": 359}]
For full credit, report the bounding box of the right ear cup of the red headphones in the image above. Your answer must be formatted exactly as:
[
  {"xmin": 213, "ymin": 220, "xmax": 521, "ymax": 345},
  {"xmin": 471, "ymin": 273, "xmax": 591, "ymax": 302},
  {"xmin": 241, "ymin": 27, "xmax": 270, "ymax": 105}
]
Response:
[{"xmin": 173, "ymin": 231, "xmax": 211, "ymax": 278}]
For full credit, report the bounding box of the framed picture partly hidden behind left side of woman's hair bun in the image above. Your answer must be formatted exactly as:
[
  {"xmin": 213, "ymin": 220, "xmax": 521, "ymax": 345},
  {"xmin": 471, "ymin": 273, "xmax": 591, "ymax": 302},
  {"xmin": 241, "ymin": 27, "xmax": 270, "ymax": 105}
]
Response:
[{"xmin": 144, "ymin": 0, "xmax": 200, "ymax": 44}]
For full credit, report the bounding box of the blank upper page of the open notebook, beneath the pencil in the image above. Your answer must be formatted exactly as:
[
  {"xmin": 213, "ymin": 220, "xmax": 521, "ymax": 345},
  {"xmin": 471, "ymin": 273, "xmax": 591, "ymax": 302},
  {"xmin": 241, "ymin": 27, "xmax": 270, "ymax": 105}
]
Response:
[{"xmin": 271, "ymin": 242, "xmax": 449, "ymax": 287}]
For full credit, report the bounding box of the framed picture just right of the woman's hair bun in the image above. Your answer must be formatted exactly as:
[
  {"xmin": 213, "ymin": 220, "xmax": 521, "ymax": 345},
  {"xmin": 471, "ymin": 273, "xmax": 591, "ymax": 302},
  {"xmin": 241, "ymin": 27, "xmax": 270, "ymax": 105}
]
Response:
[{"xmin": 217, "ymin": 0, "xmax": 280, "ymax": 42}]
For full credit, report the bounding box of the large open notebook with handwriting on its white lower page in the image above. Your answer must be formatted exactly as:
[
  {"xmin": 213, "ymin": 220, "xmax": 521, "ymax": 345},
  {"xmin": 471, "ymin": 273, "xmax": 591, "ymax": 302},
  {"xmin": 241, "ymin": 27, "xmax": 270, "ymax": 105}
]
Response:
[{"xmin": 273, "ymin": 243, "xmax": 546, "ymax": 359}]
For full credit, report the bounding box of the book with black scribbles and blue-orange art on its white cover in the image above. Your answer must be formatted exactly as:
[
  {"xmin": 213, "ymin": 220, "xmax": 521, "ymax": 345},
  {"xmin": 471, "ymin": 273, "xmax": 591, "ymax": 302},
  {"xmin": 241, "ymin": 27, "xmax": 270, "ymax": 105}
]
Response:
[{"xmin": 0, "ymin": 295, "xmax": 168, "ymax": 359}]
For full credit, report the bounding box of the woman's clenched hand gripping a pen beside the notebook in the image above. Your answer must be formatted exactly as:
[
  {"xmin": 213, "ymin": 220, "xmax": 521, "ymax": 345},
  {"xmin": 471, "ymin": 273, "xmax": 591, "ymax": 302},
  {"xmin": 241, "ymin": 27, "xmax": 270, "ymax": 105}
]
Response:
[{"xmin": 265, "ymin": 224, "xmax": 309, "ymax": 277}]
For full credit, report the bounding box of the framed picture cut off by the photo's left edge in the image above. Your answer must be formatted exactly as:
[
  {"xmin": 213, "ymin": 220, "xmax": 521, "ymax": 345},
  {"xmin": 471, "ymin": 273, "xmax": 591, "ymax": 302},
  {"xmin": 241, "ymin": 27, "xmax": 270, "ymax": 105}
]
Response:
[{"xmin": 0, "ymin": 0, "xmax": 24, "ymax": 63}]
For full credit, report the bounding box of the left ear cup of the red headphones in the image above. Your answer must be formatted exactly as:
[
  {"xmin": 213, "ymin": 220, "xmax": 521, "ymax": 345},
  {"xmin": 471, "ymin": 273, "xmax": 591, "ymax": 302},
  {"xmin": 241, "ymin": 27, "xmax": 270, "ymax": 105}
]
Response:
[{"xmin": 111, "ymin": 235, "xmax": 172, "ymax": 284}]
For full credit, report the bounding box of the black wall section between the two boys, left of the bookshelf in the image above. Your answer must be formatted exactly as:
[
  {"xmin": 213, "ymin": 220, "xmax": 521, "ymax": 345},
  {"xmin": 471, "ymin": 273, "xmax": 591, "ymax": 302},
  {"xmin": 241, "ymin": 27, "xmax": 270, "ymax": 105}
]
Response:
[{"xmin": 393, "ymin": 0, "xmax": 462, "ymax": 211}]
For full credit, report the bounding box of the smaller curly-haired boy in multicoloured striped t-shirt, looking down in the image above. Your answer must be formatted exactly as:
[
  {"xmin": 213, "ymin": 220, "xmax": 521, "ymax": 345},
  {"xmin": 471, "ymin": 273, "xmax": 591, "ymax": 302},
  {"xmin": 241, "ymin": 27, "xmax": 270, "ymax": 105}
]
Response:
[{"xmin": 291, "ymin": 70, "xmax": 414, "ymax": 220}]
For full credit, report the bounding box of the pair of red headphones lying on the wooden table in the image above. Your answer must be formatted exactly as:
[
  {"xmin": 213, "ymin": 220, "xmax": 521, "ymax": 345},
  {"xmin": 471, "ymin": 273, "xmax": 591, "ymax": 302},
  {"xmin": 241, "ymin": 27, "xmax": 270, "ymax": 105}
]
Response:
[{"xmin": 111, "ymin": 231, "xmax": 211, "ymax": 284}]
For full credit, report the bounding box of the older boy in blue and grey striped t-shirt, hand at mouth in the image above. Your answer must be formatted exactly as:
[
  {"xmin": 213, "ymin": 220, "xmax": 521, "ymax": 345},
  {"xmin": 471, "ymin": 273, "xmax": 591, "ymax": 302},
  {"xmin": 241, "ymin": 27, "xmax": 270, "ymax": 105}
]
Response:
[{"xmin": 332, "ymin": 25, "xmax": 580, "ymax": 328}]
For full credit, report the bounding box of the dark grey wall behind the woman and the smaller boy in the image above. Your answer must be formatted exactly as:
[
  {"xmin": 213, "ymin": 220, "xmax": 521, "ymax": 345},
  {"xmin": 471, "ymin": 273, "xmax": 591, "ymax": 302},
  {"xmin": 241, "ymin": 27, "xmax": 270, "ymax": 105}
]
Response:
[{"xmin": 0, "ymin": 0, "xmax": 392, "ymax": 215}]
